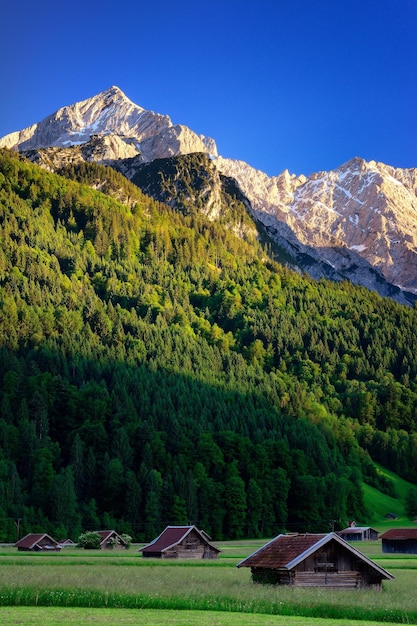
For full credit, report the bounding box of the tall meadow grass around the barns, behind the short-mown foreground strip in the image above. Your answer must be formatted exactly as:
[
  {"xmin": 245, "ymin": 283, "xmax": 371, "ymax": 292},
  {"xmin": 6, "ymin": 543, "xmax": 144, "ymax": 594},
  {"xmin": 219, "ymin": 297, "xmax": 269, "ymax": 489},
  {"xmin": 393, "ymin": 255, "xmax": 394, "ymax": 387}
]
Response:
[{"xmin": 0, "ymin": 554, "xmax": 417, "ymax": 624}]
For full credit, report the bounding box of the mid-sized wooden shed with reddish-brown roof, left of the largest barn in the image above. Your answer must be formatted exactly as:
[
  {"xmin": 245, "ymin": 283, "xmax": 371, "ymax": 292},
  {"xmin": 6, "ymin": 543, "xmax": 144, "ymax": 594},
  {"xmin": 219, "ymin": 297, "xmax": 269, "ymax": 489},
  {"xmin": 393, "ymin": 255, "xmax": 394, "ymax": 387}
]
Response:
[{"xmin": 138, "ymin": 526, "xmax": 220, "ymax": 559}]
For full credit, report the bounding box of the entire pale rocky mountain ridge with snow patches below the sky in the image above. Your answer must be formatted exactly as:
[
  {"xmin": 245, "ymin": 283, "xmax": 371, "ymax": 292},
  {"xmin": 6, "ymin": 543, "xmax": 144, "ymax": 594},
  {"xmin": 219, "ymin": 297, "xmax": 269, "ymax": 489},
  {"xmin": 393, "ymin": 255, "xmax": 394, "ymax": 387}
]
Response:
[{"xmin": 0, "ymin": 87, "xmax": 417, "ymax": 303}]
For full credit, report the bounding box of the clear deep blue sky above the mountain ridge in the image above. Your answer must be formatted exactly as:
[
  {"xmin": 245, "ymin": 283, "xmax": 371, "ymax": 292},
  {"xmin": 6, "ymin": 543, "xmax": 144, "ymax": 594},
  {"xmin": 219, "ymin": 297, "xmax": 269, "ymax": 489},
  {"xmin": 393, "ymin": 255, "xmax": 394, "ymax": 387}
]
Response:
[{"xmin": 0, "ymin": 0, "xmax": 417, "ymax": 175}]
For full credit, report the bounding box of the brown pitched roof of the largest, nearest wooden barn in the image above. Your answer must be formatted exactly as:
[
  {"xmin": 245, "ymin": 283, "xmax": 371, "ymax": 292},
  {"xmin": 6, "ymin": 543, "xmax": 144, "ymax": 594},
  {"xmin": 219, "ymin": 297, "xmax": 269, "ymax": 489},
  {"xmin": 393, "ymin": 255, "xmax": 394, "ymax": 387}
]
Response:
[{"xmin": 237, "ymin": 533, "xmax": 394, "ymax": 579}]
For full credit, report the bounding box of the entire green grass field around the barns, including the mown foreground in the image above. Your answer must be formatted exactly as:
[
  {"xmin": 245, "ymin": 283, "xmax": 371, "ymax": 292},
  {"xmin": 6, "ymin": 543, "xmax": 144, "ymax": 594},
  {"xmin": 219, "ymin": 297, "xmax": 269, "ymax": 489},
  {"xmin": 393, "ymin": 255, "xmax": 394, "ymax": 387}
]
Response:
[{"xmin": 0, "ymin": 540, "xmax": 417, "ymax": 626}]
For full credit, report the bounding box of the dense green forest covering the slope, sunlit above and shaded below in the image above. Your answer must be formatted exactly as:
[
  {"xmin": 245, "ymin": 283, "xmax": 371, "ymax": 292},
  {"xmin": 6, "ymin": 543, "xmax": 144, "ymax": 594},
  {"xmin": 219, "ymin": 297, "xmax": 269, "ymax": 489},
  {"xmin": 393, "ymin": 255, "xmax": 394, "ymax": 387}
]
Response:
[{"xmin": 0, "ymin": 150, "xmax": 417, "ymax": 541}]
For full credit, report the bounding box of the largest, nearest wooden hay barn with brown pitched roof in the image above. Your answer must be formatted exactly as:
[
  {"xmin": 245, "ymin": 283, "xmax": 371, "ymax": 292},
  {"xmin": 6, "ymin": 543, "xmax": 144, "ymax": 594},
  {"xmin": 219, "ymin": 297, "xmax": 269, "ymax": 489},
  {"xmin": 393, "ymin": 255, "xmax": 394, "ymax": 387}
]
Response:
[{"xmin": 237, "ymin": 533, "xmax": 394, "ymax": 590}]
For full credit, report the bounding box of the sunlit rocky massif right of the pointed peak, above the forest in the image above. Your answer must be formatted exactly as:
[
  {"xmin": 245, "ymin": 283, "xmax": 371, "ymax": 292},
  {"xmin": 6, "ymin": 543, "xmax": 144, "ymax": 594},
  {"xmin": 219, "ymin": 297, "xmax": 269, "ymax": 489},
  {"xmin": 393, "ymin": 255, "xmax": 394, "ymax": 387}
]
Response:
[{"xmin": 216, "ymin": 157, "xmax": 417, "ymax": 294}]
